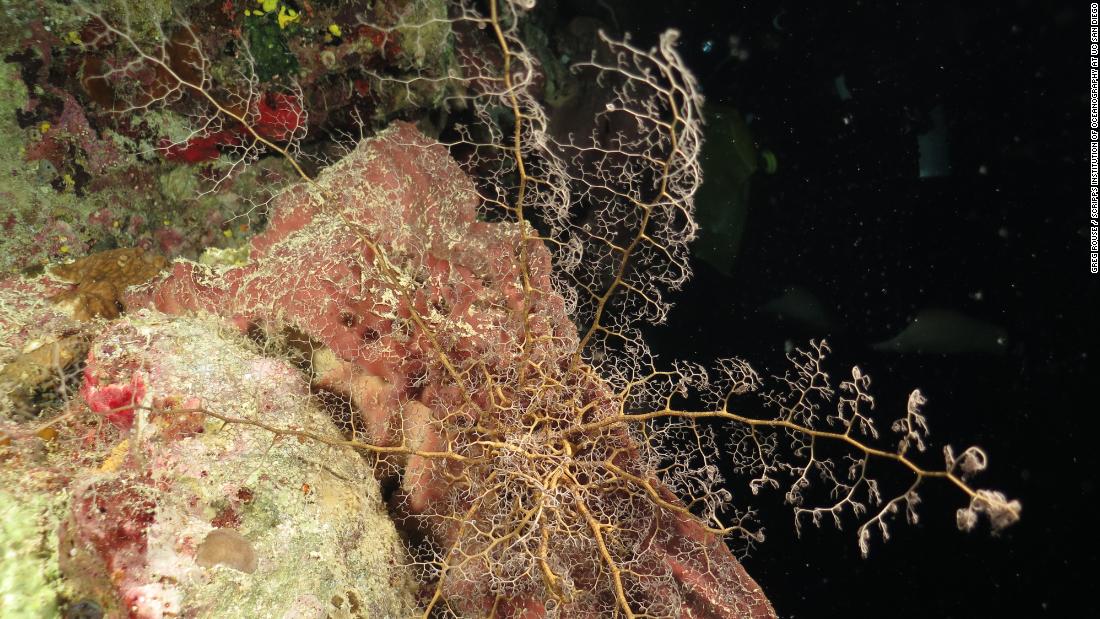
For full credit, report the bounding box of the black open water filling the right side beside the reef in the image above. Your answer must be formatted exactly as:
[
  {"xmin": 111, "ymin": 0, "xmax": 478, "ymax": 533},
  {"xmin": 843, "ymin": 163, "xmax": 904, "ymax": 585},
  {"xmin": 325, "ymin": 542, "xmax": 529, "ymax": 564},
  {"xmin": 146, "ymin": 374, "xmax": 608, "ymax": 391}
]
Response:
[{"xmin": 536, "ymin": 0, "xmax": 1086, "ymax": 617}]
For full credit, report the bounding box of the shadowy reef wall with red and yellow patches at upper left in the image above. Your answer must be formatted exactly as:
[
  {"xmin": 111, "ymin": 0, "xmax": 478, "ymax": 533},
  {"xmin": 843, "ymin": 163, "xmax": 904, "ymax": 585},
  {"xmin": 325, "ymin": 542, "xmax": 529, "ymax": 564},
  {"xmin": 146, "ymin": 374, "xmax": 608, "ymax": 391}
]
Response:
[{"xmin": 0, "ymin": 0, "xmax": 451, "ymax": 274}]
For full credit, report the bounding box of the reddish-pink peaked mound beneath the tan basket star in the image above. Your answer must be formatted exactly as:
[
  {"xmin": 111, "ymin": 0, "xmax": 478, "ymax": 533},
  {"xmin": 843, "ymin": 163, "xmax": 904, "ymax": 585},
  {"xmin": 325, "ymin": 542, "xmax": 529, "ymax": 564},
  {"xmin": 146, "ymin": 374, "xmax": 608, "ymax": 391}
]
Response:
[{"xmin": 125, "ymin": 124, "xmax": 771, "ymax": 617}]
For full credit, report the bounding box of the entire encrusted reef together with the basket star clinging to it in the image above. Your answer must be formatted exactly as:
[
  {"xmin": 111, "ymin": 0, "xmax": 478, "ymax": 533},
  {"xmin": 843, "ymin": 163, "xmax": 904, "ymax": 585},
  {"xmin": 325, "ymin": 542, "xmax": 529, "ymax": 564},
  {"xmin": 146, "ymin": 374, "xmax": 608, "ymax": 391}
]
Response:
[{"xmin": 0, "ymin": 0, "xmax": 1020, "ymax": 619}]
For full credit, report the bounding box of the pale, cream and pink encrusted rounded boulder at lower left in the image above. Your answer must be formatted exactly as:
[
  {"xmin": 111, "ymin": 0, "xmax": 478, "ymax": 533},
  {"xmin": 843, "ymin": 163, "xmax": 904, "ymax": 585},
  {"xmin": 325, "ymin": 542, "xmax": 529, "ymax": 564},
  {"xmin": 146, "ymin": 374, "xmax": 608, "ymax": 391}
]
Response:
[{"xmin": 3, "ymin": 313, "xmax": 413, "ymax": 617}]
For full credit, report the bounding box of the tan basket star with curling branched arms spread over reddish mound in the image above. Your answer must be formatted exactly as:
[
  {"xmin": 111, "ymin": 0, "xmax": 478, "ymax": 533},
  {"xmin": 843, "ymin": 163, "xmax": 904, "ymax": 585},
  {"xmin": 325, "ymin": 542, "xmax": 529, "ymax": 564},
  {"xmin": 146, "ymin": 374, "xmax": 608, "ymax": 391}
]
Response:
[{"xmin": 8, "ymin": 0, "xmax": 1020, "ymax": 618}]
